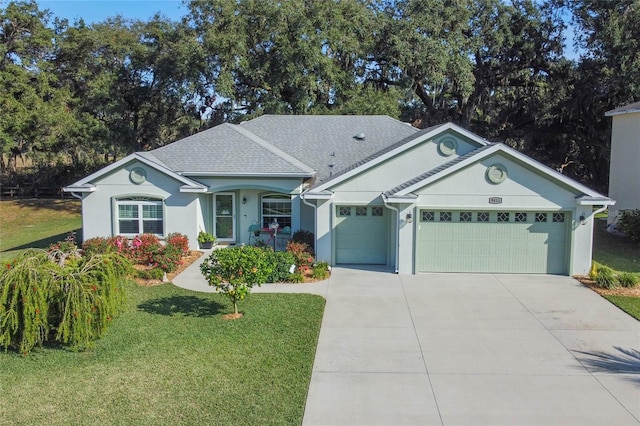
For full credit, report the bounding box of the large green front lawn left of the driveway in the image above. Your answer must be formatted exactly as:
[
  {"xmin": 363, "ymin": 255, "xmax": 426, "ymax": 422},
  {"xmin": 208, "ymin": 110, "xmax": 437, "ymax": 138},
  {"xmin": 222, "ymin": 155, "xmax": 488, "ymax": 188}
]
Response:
[{"xmin": 0, "ymin": 284, "xmax": 324, "ymax": 425}]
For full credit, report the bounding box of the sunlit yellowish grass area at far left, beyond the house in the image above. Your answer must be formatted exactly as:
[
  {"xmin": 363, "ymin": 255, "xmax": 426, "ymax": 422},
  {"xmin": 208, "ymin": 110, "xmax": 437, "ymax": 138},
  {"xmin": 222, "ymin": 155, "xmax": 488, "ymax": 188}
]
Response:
[{"xmin": 0, "ymin": 199, "xmax": 82, "ymax": 259}]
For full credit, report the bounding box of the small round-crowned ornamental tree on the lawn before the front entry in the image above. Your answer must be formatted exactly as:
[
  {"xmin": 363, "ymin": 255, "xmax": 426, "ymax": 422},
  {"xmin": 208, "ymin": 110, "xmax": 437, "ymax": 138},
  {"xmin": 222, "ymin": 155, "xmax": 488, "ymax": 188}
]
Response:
[{"xmin": 200, "ymin": 246, "xmax": 273, "ymax": 318}]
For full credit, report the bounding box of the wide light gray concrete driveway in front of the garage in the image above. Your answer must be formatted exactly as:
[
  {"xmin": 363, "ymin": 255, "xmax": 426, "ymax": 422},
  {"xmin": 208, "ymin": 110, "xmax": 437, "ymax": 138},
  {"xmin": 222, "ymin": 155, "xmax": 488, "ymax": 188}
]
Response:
[{"xmin": 302, "ymin": 268, "xmax": 640, "ymax": 426}]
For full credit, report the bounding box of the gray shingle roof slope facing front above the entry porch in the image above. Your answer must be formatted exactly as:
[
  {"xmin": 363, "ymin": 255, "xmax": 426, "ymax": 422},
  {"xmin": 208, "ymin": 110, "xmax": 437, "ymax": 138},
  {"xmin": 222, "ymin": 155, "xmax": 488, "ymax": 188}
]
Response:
[{"xmin": 150, "ymin": 124, "xmax": 313, "ymax": 176}]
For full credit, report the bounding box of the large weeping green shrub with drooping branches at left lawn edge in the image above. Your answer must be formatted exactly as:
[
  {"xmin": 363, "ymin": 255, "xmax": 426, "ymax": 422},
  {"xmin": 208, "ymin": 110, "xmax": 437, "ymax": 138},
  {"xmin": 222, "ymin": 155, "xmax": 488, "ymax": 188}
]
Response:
[{"xmin": 0, "ymin": 250, "xmax": 132, "ymax": 354}]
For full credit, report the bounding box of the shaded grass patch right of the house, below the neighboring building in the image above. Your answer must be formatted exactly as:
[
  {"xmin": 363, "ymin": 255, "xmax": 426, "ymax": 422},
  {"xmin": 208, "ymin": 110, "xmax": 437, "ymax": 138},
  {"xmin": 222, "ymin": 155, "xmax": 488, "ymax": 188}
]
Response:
[{"xmin": 593, "ymin": 220, "xmax": 640, "ymax": 272}]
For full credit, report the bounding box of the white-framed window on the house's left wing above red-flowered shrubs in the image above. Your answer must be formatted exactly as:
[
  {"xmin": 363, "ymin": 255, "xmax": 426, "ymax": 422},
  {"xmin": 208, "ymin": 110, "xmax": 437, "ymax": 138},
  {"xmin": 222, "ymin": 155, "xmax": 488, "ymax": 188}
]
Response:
[{"xmin": 116, "ymin": 197, "xmax": 164, "ymax": 235}]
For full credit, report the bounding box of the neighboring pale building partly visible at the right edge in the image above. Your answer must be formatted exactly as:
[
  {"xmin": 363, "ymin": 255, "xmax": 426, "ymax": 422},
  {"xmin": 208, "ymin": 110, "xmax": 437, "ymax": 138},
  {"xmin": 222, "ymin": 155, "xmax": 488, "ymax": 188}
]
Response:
[{"xmin": 605, "ymin": 102, "xmax": 640, "ymax": 230}]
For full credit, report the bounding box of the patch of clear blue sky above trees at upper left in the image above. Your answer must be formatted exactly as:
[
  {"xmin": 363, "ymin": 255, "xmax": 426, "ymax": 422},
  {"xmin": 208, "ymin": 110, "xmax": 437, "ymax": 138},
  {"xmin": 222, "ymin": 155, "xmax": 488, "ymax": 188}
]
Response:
[{"xmin": 37, "ymin": 0, "xmax": 187, "ymax": 24}]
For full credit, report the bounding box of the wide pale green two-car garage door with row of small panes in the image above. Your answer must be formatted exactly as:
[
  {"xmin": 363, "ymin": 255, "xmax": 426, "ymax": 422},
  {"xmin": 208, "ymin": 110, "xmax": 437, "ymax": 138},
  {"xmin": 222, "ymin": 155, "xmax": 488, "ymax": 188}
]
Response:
[{"xmin": 415, "ymin": 209, "xmax": 570, "ymax": 274}]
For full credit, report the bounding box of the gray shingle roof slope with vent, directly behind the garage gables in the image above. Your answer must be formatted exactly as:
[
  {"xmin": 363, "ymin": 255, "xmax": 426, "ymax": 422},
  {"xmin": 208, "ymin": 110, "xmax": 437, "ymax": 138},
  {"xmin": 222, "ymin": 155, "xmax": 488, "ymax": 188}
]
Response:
[{"xmin": 240, "ymin": 115, "xmax": 418, "ymax": 183}]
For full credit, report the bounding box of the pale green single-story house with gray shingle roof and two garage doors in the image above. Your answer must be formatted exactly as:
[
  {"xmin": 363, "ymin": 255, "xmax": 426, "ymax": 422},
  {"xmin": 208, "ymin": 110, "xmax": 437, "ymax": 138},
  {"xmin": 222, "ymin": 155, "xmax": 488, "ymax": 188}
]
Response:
[{"xmin": 65, "ymin": 115, "xmax": 614, "ymax": 274}]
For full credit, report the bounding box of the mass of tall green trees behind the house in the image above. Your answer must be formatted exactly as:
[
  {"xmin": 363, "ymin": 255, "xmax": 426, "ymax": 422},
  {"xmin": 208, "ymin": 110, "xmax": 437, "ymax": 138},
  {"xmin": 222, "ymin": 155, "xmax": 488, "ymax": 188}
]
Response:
[{"xmin": 0, "ymin": 0, "xmax": 640, "ymax": 191}]
